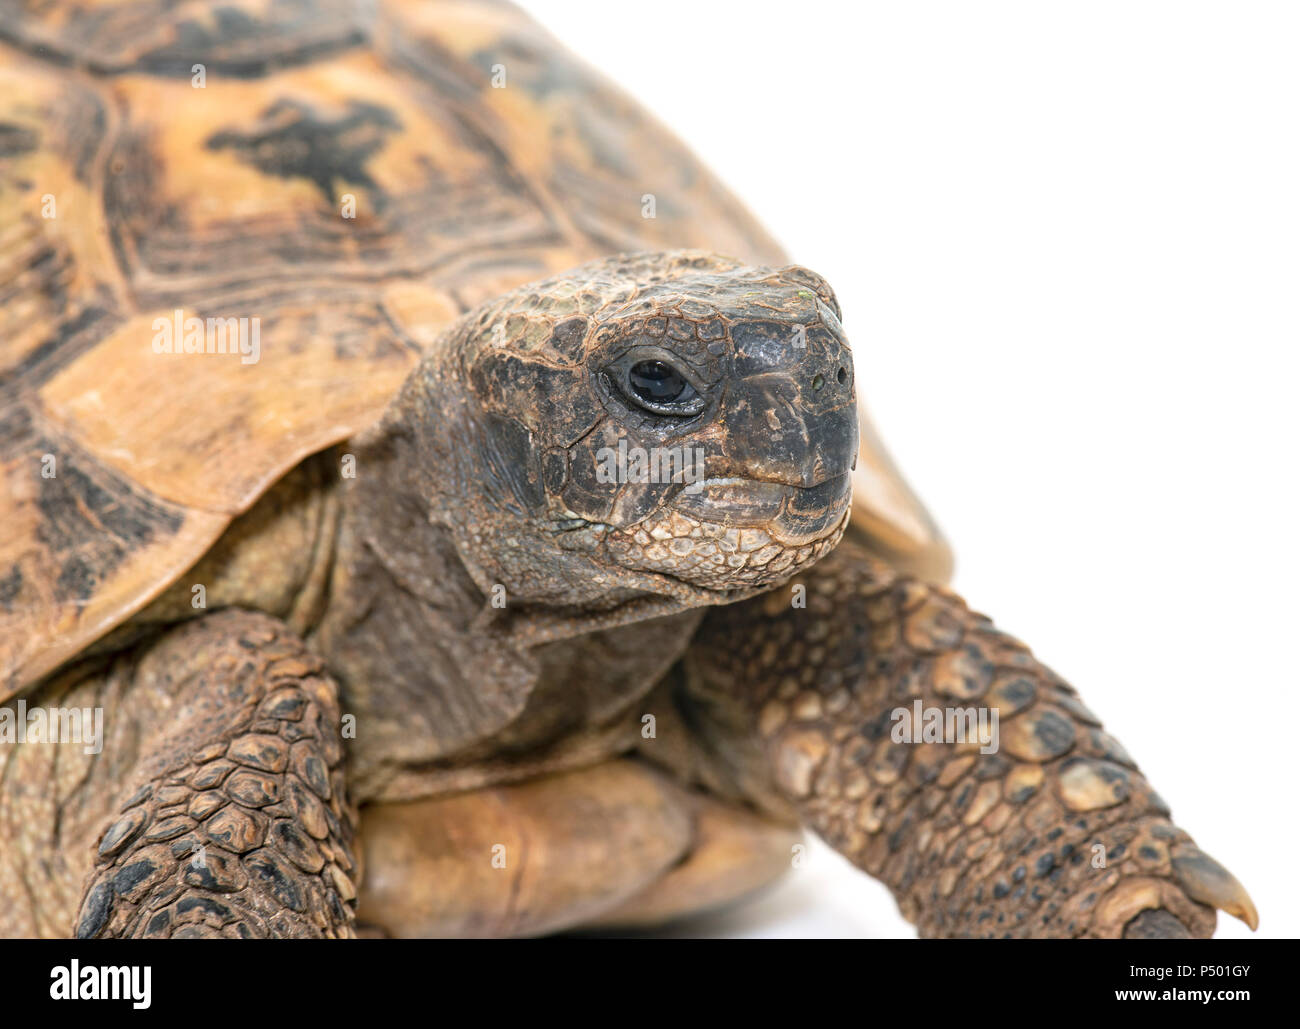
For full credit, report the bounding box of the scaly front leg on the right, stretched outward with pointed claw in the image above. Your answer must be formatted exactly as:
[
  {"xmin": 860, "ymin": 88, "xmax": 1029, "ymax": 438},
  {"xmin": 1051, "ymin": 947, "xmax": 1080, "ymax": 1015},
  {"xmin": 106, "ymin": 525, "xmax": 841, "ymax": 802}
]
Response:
[{"xmin": 688, "ymin": 540, "xmax": 1257, "ymax": 938}]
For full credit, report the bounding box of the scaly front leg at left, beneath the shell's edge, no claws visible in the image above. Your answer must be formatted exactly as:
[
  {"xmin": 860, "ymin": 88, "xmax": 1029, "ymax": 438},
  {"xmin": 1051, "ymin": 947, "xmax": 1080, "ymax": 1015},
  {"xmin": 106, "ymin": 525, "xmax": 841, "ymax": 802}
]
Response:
[{"xmin": 75, "ymin": 611, "xmax": 358, "ymax": 938}]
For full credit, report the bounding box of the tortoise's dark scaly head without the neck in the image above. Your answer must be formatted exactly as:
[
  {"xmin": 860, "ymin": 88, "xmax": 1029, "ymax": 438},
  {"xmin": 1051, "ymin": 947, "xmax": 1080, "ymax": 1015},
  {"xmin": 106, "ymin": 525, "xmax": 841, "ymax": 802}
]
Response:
[{"xmin": 400, "ymin": 252, "xmax": 858, "ymax": 604}]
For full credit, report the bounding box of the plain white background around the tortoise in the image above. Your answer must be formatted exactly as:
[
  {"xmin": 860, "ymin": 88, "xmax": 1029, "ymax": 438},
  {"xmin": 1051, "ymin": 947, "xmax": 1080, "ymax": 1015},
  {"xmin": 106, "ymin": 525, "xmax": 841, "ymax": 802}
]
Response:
[{"xmin": 524, "ymin": 0, "xmax": 1300, "ymax": 937}]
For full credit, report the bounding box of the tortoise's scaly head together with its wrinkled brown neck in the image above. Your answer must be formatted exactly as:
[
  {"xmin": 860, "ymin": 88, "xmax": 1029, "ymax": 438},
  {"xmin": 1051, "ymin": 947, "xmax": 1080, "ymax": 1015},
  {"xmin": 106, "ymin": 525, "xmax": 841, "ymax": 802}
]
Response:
[{"xmin": 313, "ymin": 253, "xmax": 857, "ymax": 799}]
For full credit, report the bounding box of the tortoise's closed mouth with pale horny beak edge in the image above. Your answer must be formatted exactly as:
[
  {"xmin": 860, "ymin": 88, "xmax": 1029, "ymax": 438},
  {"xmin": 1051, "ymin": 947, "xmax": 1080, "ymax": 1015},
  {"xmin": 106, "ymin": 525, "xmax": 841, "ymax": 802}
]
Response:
[{"xmin": 673, "ymin": 473, "xmax": 853, "ymax": 547}]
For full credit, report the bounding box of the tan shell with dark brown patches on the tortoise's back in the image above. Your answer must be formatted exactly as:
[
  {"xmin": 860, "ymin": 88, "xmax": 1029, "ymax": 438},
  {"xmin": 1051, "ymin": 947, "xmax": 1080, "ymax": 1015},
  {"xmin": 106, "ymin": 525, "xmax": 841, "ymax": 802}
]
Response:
[{"xmin": 0, "ymin": 0, "xmax": 944, "ymax": 698}]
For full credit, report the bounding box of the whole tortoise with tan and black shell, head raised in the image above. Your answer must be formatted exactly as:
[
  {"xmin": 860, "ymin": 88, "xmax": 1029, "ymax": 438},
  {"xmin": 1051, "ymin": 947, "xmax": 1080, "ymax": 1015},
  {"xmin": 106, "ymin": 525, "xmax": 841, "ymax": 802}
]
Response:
[{"xmin": 0, "ymin": 0, "xmax": 1256, "ymax": 938}]
